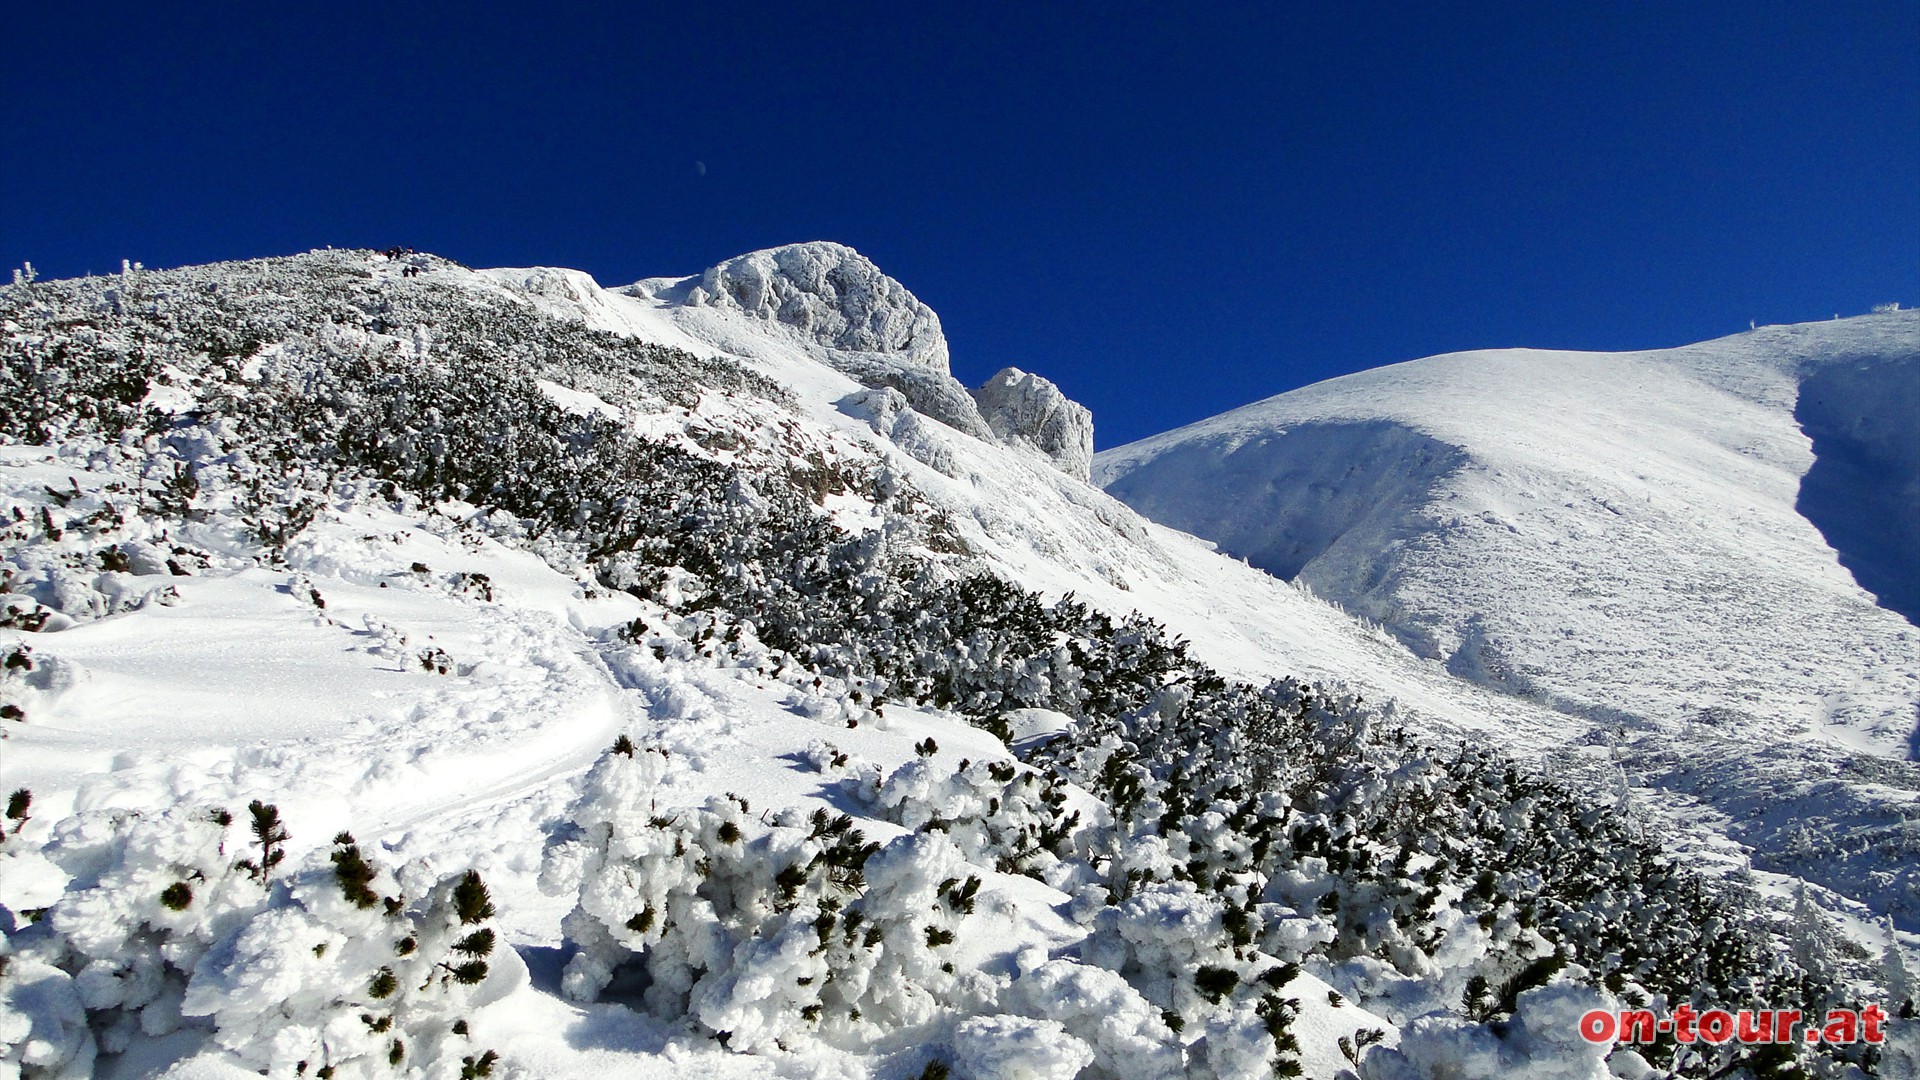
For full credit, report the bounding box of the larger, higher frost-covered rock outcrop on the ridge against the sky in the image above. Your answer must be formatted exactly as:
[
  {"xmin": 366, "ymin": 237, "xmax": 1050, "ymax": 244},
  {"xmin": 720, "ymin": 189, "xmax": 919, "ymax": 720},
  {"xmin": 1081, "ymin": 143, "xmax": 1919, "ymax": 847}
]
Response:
[{"xmin": 685, "ymin": 240, "xmax": 947, "ymax": 375}]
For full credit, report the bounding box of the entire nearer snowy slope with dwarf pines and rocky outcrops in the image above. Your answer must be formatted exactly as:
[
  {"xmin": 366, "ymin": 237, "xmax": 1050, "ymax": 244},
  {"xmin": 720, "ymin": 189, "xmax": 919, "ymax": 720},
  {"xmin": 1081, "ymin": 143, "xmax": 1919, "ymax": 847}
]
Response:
[{"xmin": 0, "ymin": 244, "xmax": 1912, "ymax": 1080}]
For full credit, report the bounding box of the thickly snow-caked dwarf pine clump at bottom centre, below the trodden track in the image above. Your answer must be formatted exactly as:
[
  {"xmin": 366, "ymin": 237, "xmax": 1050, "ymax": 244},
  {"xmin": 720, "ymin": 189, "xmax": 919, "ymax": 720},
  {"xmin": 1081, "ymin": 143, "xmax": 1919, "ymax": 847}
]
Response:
[{"xmin": 543, "ymin": 742, "xmax": 995, "ymax": 1051}]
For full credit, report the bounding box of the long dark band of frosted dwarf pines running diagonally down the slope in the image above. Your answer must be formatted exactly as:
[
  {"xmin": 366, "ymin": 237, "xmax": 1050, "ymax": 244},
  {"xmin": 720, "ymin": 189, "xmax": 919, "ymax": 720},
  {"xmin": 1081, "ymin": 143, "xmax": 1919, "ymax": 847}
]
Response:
[{"xmin": 0, "ymin": 252, "xmax": 1837, "ymax": 1074}]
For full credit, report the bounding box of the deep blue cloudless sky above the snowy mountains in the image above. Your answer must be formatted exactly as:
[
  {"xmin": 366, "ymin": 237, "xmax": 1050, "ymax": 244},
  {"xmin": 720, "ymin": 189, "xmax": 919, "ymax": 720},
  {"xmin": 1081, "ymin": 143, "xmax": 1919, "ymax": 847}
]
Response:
[{"xmin": 0, "ymin": 0, "xmax": 1920, "ymax": 446}]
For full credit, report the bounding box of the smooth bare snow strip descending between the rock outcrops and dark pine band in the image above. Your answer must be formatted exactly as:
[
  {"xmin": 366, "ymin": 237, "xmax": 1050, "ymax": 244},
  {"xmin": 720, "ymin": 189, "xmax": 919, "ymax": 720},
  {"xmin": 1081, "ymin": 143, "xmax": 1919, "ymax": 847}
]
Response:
[{"xmin": 591, "ymin": 245, "xmax": 1597, "ymax": 748}]
